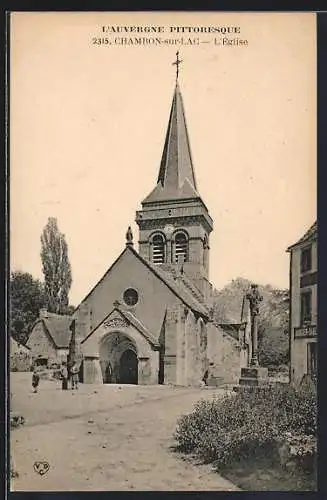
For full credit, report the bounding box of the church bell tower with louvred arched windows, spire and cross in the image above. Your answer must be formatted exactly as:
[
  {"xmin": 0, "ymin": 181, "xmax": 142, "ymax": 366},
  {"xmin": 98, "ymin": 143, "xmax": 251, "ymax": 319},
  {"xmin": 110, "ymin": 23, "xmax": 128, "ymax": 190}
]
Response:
[{"xmin": 136, "ymin": 53, "xmax": 213, "ymax": 295}]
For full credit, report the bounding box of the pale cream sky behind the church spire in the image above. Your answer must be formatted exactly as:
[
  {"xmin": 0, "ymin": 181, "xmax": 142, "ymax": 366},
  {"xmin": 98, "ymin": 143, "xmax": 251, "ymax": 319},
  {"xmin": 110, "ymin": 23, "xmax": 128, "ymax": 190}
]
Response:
[{"xmin": 10, "ymin": 12, "xmax": 317, "ymax": 305}]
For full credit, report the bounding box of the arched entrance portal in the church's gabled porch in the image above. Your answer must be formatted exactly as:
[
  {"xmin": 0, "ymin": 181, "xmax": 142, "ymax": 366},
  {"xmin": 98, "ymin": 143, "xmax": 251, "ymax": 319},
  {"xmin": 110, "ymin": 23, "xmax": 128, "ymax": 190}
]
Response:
[{"xmin": 99, "ymin": 332, "xmax": 138, "ymax": 384}]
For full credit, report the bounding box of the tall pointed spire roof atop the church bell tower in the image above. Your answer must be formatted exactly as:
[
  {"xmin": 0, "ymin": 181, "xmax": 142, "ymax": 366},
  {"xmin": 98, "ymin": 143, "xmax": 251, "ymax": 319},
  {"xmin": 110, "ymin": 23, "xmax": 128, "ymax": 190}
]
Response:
[{"xmin": 142, "ymin": 83, "xmax": 200, "ymax": 204}]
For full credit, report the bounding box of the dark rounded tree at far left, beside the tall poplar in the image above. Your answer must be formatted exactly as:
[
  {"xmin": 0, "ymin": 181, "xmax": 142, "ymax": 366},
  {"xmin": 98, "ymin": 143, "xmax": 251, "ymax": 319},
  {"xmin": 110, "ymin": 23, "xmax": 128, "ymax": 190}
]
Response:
[{"xmin": 9, "ymin": 271, "xmax": 45, "ymax": 344}]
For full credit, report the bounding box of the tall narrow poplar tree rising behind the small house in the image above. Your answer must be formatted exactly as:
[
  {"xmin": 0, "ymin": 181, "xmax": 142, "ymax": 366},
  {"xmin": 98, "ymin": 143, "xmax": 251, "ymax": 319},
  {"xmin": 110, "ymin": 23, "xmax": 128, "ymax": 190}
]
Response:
[{"xmin": 41, "ymin": 217, "xmax": 72, "ymax": 314}]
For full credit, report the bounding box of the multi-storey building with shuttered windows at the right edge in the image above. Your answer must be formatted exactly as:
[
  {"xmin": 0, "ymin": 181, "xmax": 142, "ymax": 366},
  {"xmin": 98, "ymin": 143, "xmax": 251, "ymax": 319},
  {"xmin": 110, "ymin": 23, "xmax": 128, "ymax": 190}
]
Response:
[{"xmin": 287, "ymin": 222, "xmax": 318, "ymax": 382}]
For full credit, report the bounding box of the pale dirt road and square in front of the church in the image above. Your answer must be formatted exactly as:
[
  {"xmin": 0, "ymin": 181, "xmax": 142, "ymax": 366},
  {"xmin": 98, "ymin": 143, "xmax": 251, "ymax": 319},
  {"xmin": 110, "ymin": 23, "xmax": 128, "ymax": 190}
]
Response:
[{"xmin": 11, "ymin": 374, "xmax": 238, "ymax": 491}]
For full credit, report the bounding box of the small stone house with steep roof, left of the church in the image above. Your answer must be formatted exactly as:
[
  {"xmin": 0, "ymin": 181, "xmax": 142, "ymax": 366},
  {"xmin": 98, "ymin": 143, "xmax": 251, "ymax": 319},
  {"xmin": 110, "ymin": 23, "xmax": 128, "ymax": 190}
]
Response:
[{"xmin": 26, "ymin": 309, "xmax": 72, "ymax": 366}]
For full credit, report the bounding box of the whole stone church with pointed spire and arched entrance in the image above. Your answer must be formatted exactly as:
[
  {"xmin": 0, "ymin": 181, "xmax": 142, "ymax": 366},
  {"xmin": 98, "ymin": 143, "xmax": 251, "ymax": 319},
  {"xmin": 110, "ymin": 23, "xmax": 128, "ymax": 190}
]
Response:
[{"xmin": 71, "ymin": 82, "xmax": 250, "ymax": 385}]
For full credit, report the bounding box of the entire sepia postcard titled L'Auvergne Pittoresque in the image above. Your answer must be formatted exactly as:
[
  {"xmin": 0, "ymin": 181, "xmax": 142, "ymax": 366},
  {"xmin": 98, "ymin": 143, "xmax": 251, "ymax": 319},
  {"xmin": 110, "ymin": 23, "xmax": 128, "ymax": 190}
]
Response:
[{"xmin": 8, "ymin": 12, "xmax": 318, "ymax": 492}]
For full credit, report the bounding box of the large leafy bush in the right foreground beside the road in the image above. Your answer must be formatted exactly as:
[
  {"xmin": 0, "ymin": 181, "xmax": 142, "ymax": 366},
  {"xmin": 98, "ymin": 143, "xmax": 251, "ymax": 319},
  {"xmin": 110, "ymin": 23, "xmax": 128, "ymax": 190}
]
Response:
[{"xmin": 175, "ymin": 384, "xmax": 317, "ymax": 466}]
